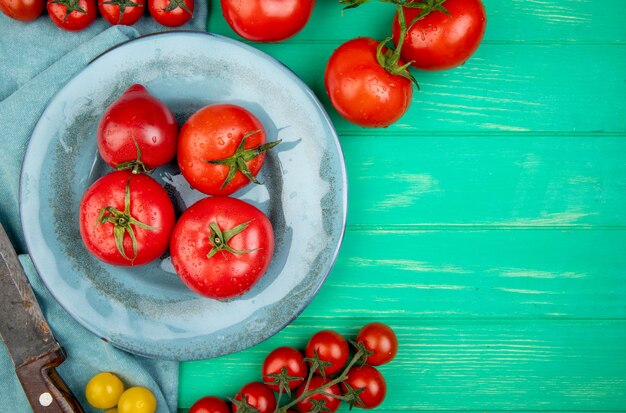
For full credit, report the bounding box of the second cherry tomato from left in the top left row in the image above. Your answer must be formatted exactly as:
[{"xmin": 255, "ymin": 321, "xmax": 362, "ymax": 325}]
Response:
[{"xmin": 46, "ymin": 0, "xmax": 97, "ymax": 32}]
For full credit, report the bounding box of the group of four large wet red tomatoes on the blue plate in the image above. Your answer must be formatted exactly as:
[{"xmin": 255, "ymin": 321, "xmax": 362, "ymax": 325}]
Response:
[{"xmin": 79, "ymin": 84, "xmax": 279, "ymax": 299}]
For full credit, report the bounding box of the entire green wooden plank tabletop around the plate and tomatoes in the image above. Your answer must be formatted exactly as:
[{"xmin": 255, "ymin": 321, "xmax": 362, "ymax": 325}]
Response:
[{"xmin": 179, "ymin": 0, "xmax": 626, "ymax": 412}]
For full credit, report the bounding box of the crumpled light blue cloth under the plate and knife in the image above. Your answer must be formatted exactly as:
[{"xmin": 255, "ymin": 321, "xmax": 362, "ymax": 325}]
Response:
[{"xmin": 0, "ymin": 1, "xmax": 208, "ymax": 413}]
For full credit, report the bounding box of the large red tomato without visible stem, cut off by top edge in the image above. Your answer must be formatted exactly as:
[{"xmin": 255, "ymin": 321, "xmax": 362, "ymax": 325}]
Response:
[{"xmin": 221, "ymin": 0, "xmax": 315, "ymax": 42}]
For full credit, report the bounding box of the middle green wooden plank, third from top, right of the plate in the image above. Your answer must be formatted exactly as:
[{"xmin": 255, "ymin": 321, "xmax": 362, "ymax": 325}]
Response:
[{"xmin": 341, "ymin": 132, "xmax": 626, "ymax": 228}]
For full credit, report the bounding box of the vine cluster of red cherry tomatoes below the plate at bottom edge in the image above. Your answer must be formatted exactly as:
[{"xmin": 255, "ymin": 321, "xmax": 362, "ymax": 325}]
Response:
[{"xmin": 189, "ymin": 322, "xmax": 398, "ymax": 413}]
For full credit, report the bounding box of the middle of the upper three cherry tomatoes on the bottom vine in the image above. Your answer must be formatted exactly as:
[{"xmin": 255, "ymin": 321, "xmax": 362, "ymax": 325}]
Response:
[{"xmin": 304, "ymin": 330, "xmax": 350, "ymax": 376}]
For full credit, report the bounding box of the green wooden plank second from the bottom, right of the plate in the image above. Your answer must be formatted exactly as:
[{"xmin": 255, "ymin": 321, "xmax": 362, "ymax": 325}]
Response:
[{"xmin": 294, "ymin": 230, "xmax": 626, "ymax": 322}]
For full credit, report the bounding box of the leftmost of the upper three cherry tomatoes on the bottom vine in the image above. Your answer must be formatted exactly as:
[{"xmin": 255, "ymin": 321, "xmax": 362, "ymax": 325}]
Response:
[{"xmin": 262, "ymin": 347, "xmax": 308, "ymax": 392}]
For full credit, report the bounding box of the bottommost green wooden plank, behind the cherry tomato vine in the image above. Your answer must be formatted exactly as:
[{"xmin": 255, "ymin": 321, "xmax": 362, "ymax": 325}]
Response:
[{"xmin": 179, "ymin": 318, "xmax": 626, "ymax": 411}]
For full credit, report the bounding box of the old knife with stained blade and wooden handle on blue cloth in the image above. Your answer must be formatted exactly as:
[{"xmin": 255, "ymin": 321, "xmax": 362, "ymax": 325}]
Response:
[{"xmin": 0, "ymin": 225, "xmax": 83, "ymax": 413}]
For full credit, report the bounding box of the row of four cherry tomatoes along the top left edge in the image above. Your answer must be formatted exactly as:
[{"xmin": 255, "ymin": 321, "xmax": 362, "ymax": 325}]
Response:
[{"xmin": 0, "ymin": 0, "xmax": 194, "ymax": 31}]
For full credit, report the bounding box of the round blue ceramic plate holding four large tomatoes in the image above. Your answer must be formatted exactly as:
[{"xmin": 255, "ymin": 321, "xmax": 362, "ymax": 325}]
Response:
[{"xmin": 20, "ymin": 32, "xmax": 347, "ymax": 360}]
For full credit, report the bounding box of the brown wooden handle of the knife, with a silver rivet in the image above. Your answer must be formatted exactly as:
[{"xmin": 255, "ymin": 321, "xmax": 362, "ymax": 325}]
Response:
[{"xmin": 15, "ymin": 349, "xmax": 84, "ymax": 413}]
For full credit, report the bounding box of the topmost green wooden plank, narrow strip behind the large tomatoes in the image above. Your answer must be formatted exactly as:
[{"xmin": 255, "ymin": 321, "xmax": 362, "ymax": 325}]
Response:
[{"xmin": 208, "ymin": 0, "xmax": 626, "ymax": 43}]
